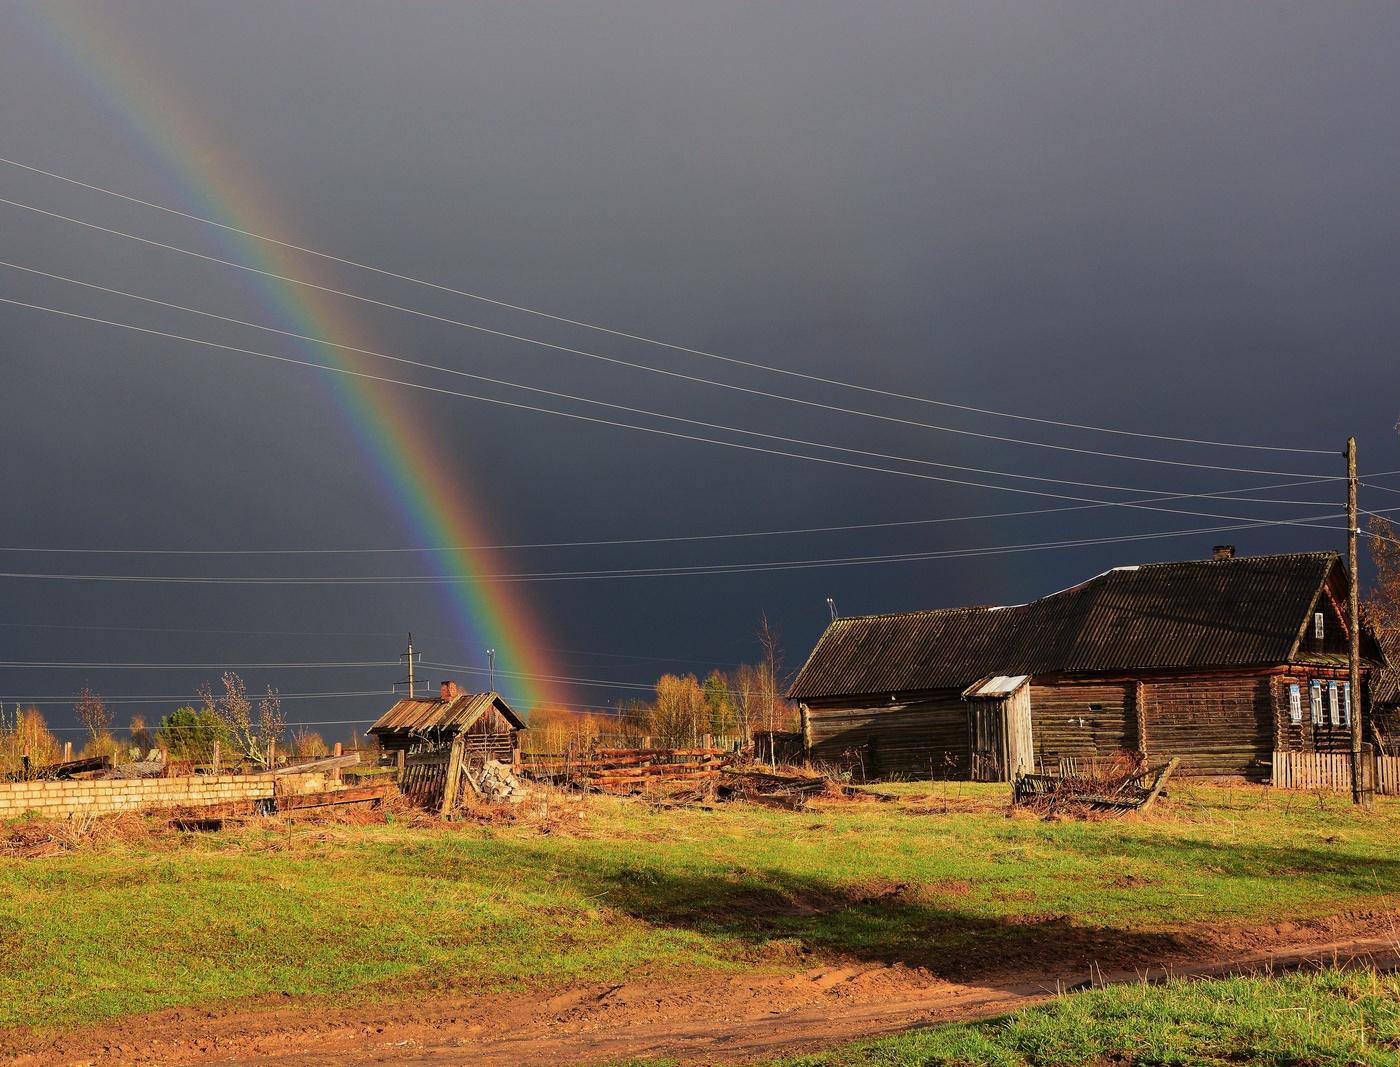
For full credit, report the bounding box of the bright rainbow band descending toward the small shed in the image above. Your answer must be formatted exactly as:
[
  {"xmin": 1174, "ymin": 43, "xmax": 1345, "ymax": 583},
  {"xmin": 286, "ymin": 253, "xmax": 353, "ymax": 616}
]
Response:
[{"xmin": 18, "ymin": 4, "xmax": 567, "ymax": 711}]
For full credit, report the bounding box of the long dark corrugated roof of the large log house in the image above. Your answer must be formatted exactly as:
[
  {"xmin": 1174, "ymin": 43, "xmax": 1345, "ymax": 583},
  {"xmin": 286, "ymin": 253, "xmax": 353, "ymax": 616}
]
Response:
[{"xmin": 788, "ymin": 552, "xmax": 1383, "ymax": 700}]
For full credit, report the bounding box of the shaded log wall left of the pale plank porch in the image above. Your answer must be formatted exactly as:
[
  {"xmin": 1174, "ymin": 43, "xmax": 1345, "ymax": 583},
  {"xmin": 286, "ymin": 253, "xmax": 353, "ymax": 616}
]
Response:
[{"xmin": 806, "ymin": 690, "xmax": 969, "ymax": 780}]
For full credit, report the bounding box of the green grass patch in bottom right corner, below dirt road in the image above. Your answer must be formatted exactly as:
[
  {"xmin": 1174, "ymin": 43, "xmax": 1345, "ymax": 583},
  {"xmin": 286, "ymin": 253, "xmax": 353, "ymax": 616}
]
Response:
[{"xmin": 771, "ymin": 970, "xmax": 1400, "ymax": 1067}]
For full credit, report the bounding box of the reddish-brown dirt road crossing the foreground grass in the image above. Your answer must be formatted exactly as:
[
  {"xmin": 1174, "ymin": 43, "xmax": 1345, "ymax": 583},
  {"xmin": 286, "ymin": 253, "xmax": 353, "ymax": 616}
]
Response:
[{"xmin": 13, "ymin": 916, "xmax": 1400, "ymax": 1067}]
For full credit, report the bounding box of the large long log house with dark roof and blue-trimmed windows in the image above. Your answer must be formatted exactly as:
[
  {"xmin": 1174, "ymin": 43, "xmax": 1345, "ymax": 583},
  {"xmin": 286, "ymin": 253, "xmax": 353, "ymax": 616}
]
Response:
[{"xmin": 788, "ymin": 549, "xmax": 1387, "ymax": 780}]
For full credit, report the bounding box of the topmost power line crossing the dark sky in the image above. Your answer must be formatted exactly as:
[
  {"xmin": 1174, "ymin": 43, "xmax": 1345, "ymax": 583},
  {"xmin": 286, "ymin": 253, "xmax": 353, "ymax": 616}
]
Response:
[{"xmin": 0, "ymin": 157, "xmax": 1333, "ymax": 455}]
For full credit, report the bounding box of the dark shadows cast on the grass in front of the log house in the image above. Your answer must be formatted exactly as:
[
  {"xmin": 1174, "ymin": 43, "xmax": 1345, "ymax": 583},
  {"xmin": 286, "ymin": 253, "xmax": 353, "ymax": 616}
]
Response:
[{"xmin": 551, "ymin": 842, "xmax": 1400, "ymax": 980}]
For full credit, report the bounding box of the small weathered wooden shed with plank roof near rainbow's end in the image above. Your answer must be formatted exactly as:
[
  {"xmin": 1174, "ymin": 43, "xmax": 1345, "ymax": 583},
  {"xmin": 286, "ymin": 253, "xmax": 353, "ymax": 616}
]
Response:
[{"xmin": 368, "ymin": 682, "xmax": 526, "ymax": 765}]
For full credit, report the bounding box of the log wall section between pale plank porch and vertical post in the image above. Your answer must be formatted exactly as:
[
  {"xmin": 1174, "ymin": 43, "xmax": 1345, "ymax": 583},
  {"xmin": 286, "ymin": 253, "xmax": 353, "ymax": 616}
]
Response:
[{"xmin": 1030, "ymin": 681, "xmax": 1138, "ymax": 770}]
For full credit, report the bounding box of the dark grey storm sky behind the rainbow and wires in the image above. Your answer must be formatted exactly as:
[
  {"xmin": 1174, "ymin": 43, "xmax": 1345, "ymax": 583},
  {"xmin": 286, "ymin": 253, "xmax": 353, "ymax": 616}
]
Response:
[{"xmin": 0, "ymin": 0, "xmax": 1400, "ymax": 738}]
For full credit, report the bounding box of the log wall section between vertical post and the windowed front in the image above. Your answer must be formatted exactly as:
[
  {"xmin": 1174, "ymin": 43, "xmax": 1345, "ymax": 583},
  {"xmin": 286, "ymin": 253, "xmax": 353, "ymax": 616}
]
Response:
[{"xmin": 1142, "ymin": 674, "xmax": 1288, "ymax": 781}]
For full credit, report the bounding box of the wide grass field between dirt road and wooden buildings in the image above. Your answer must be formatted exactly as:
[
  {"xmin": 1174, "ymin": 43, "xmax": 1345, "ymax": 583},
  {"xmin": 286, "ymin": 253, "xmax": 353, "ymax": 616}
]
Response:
[{"xmin": 0, "ymin": 786, "xmax": 1400, "ymax": 1030}]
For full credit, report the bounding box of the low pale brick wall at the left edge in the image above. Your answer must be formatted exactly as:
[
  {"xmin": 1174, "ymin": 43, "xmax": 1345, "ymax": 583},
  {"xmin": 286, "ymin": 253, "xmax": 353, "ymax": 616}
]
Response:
[{"xmin": 0, "ymin": 774, "xmax": 337, "ymax": 821}]
